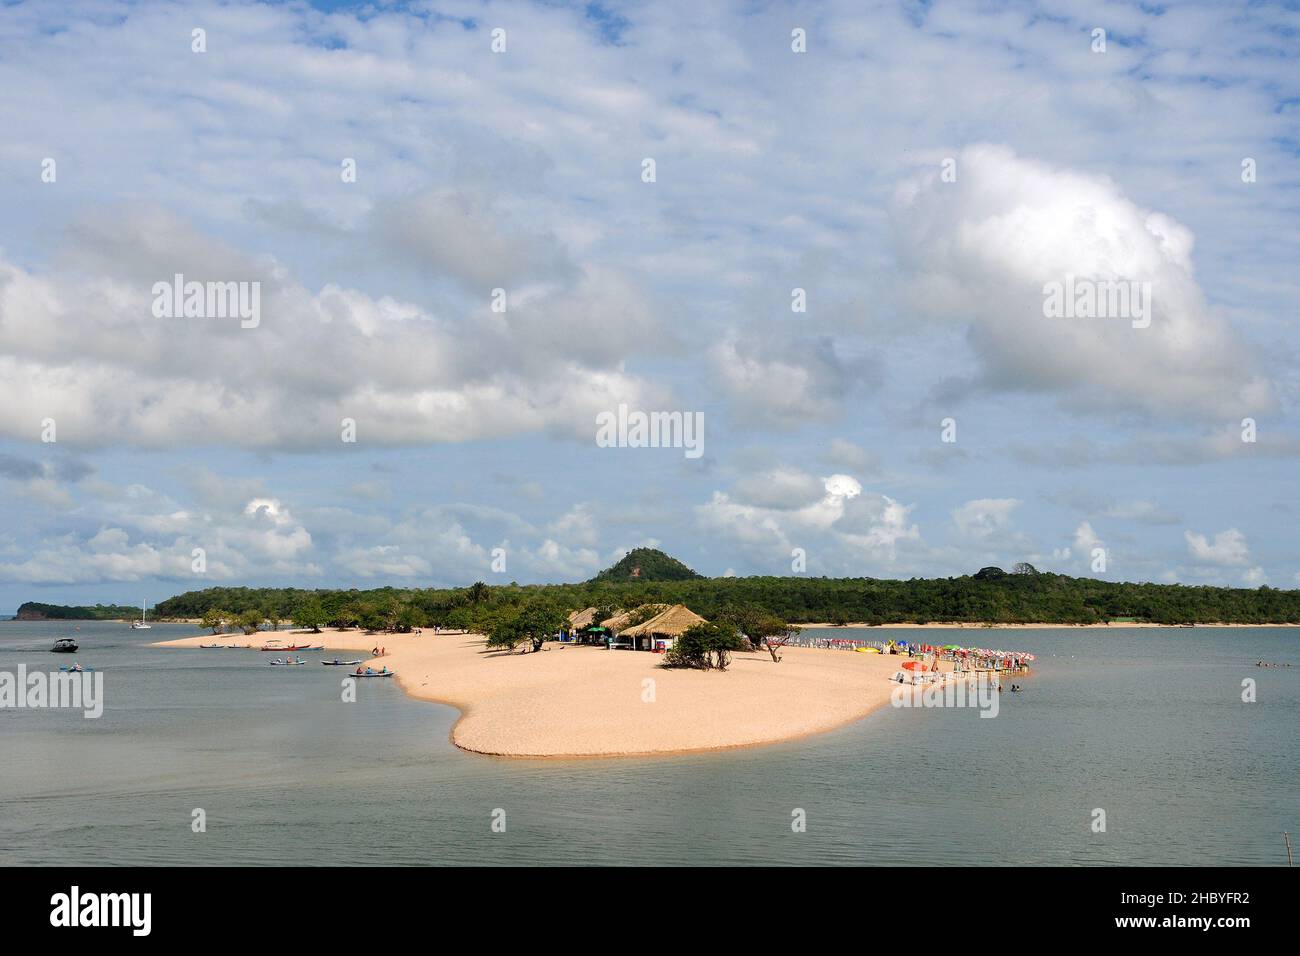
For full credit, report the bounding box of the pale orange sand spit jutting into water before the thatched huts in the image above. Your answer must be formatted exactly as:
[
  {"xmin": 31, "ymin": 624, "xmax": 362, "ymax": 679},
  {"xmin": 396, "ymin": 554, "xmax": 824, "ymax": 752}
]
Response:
[{"xmin": 157, "ymin": 630, "xmax": 930, "ymax": 757}]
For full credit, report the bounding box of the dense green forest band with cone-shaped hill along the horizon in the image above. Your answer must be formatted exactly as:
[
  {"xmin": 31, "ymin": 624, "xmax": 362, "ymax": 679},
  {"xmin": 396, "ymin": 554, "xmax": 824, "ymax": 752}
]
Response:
[{"xmin": 23, "ymin": 549, "xmax": 1300, "ymax": 631}]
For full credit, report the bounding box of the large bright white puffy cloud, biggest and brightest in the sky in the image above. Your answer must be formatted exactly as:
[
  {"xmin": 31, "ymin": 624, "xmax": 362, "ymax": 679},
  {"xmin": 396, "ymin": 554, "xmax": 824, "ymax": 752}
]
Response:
[{"xmin": 892, "ymin": 144, "xmax": 1274, "ymax": 420}]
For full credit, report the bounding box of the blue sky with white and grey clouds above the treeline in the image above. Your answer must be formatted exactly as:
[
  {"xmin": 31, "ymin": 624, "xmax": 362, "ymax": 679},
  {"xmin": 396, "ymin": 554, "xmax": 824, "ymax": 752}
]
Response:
[{"xmin": 0, "ymin": 0, "xmax": 1300, "ymax": 610}]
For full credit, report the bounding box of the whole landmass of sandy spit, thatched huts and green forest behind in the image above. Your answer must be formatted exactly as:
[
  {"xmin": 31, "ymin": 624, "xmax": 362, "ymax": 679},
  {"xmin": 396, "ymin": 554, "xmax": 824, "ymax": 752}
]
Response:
[{"xmin": 131, "ymin": 549, "xmax": 1300, "ymax": 757}]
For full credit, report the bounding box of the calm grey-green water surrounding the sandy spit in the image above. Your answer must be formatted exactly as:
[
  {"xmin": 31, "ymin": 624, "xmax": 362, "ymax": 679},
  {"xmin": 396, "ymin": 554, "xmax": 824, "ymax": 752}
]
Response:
[{"xmin": 0, "ymin": 622, "xmax": 1300, "ymax": 865}]
